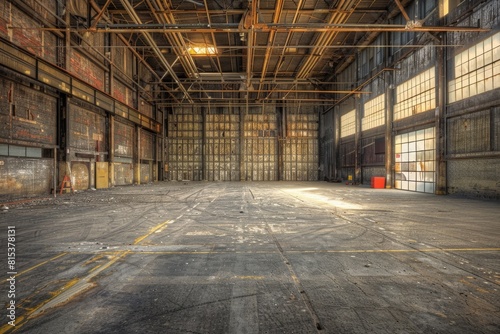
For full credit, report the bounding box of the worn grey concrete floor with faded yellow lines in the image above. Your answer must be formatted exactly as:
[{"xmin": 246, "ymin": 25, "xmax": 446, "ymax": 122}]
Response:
[{"xmin": 0, "ymin": 182, "xmax": 500, "ymax": 334}]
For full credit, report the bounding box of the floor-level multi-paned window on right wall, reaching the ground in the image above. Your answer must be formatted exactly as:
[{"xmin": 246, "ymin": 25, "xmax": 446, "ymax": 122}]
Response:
[{"xmin": 394, "ymin": 127, "xmax": 436, "ymax": 193}]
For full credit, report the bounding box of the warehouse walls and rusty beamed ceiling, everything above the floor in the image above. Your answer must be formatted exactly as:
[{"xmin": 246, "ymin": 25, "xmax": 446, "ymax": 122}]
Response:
[{"xmin": 0, "ymin": 0, "xmax": 500, "ymax": 199}]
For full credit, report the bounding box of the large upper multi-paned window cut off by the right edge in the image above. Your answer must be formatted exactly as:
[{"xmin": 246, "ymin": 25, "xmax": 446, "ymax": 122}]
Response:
[{"xmin": 448, "ymin": 33, "xmax": 500, "ymax": 103}]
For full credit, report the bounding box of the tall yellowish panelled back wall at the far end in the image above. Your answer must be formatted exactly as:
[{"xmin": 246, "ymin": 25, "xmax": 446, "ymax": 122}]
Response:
[{"xmin": 167, "ymin": 108, "xmax": 318, "ymax": 181}]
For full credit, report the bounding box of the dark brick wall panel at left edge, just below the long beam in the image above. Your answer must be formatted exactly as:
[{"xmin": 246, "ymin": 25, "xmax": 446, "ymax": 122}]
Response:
[{"xmin": 0, "ymin": 78, "xmax": 57, "ymax": 146}]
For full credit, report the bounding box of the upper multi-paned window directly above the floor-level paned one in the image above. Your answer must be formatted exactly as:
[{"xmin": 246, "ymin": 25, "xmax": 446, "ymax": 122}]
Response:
[{"xmin": 394, "ymin": 67, "xmax": 436, "ymax": 120}]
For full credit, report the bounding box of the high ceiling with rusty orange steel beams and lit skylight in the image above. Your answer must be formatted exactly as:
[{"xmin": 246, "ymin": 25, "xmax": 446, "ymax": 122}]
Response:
[{"xmin": 85, "ymin": 0, "xmax": 476, "ymax": 107}]
